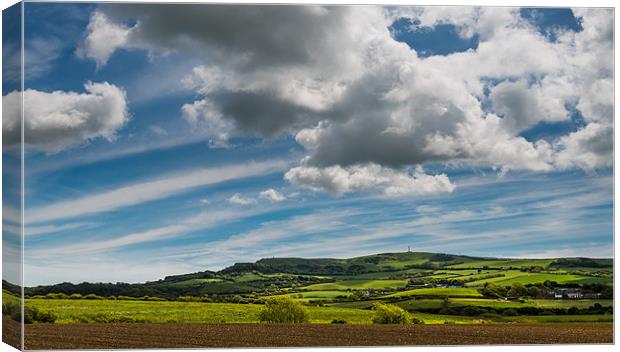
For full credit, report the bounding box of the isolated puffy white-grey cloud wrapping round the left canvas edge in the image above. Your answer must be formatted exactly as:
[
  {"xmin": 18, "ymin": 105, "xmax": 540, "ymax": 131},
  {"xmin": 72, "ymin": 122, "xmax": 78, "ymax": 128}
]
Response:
[{"xmin": 2, "ymin": 82, "xmax": 129, "ymax": 152}]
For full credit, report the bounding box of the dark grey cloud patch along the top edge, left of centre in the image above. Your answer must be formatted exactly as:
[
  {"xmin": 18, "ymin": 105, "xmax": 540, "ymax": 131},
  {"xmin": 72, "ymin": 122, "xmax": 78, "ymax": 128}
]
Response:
[{"xmin": 101, "ymin": 4, "xmax": 348, "ymax": 67}]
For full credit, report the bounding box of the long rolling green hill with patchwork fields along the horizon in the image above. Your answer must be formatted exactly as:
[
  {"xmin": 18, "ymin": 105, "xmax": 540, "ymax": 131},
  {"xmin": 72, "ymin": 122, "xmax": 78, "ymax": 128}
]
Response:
[{"xmin": 3, "ymin": 252, "xmax": 613, "ymax": 298}]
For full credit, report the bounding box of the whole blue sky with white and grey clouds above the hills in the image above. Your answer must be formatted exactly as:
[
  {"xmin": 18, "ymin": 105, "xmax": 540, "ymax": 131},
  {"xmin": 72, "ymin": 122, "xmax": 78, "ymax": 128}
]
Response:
[{"xmin": 2, "ymin": 3, "xmax": 613, "ymax": 286}]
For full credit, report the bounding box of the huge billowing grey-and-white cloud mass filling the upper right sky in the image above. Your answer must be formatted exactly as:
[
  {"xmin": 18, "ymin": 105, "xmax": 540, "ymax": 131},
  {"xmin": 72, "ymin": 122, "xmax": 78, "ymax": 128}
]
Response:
[{"xmin": 78, "ymin": 4, "xmax": 613, "ymax": 194}]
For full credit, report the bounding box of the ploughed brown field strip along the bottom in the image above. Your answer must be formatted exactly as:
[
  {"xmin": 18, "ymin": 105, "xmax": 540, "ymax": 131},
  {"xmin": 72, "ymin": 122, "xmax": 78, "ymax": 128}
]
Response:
[{"xmin": 26, "ymin": 323, "xmax": 613, "ymax": 349}]
